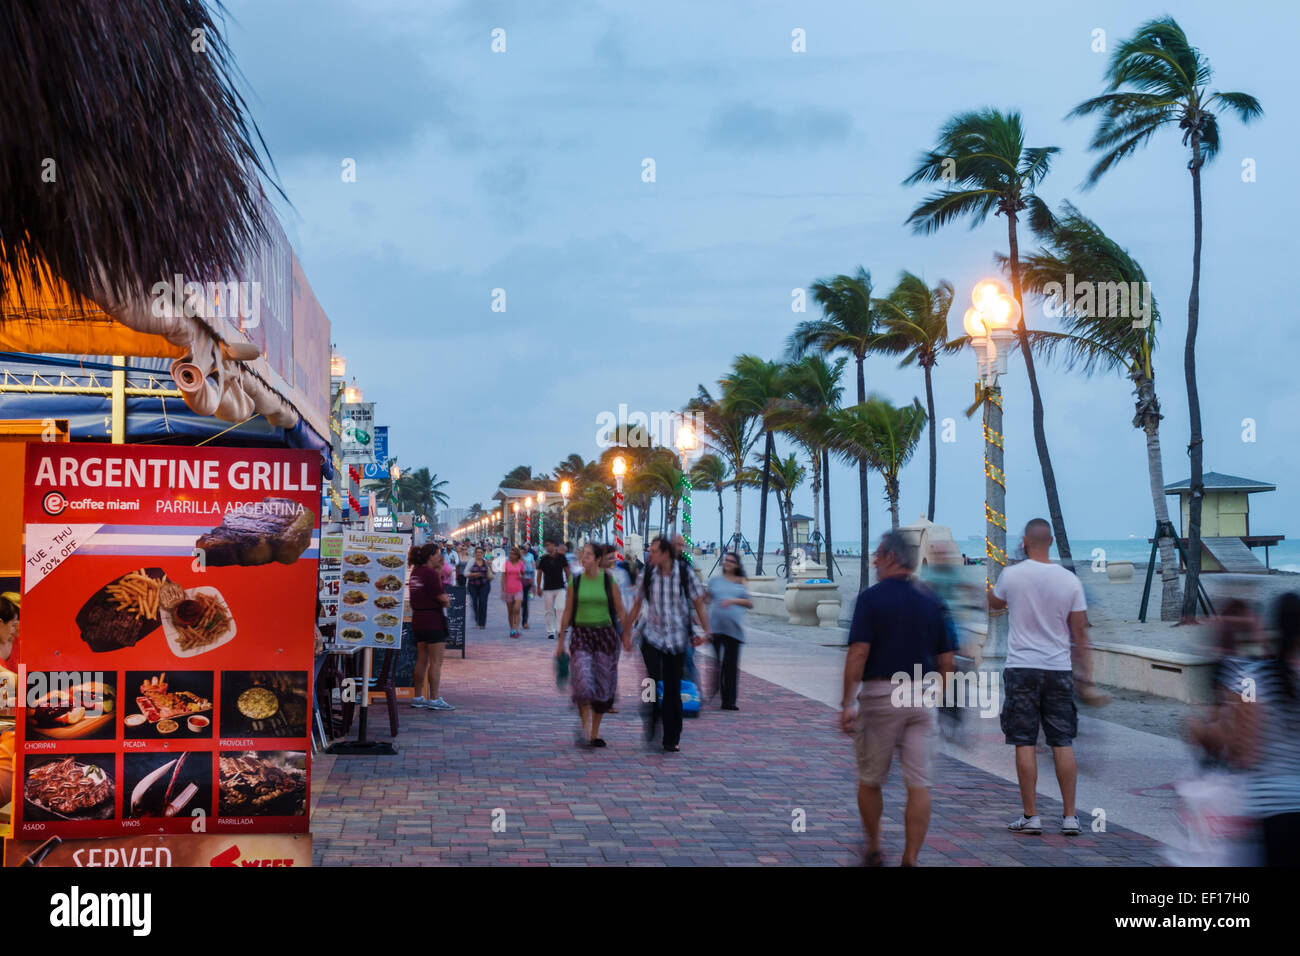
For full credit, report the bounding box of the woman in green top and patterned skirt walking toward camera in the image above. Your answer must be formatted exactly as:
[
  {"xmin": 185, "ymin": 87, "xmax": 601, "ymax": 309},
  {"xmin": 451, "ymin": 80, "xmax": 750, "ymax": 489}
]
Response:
[{"xmin": 555, "ymin": 544, "xmax": 632, "ymax": 747}]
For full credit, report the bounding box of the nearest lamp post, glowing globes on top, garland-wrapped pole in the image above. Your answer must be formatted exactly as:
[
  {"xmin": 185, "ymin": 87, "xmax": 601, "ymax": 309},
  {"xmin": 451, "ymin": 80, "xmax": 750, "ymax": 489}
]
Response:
[{"xmin": 962, "ymin": 280, "xmax": 1021, "ymax": 659}]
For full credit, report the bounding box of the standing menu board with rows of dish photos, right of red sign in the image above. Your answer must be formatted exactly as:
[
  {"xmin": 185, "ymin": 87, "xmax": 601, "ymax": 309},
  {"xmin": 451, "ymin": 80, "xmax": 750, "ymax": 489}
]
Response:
[{"xmin": 334, "ymin": 531, "xmax": 411, "ymax": 650}]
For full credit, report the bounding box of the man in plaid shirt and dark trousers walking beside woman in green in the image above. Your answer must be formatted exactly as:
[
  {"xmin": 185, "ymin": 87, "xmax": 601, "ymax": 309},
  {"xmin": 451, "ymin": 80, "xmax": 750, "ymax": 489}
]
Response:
[{"xmin": 623, "ymin": 537, "xmax": 709, "ymax": 753}]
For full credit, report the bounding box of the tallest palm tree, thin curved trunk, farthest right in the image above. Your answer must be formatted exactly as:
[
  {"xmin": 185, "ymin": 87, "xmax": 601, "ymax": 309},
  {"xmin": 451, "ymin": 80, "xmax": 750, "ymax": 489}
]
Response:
[{"xmin": 1070, "ymin": 17, "xmax": 1264, "ymax": 619}]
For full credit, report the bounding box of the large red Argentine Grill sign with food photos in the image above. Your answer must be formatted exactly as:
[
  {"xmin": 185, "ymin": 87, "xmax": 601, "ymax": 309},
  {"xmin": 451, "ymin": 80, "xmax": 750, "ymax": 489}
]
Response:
[{"xmin": 14, "ymin": 444, "xmax": 320, "ymax": 840}]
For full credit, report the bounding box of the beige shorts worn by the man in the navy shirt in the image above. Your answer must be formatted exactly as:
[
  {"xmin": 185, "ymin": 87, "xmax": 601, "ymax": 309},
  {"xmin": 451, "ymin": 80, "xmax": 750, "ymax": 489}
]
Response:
[{"xmin": 853, "ymin": 680, "xmax": 937, "ymax": 787}]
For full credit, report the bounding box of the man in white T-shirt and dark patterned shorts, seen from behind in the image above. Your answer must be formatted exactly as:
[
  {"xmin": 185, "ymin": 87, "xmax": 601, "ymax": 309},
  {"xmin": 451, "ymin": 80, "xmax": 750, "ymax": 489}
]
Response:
[{"xmin": 988, "ymin": 518, "xmax": 1105, "ymax": 836}]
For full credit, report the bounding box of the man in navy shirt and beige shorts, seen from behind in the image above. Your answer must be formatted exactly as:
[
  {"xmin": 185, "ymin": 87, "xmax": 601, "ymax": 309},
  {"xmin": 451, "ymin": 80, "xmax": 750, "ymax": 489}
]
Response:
[{"xmin": 840, "ymin": 532, "xmax": 957, "ymax": 866}]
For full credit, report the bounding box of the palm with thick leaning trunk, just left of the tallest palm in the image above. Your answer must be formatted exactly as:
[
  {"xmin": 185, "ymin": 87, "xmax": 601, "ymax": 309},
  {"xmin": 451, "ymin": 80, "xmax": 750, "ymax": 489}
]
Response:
[{"xmin": 1008, "ymin": 203, "xmax": 1182, "ymax": 620}]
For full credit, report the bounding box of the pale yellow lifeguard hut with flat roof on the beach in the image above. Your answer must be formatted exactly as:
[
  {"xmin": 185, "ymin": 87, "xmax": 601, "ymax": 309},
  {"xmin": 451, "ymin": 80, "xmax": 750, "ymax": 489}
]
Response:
[{"xmin": 1165, "ymin": 471, "xmax": 1286, "ymax": 574}]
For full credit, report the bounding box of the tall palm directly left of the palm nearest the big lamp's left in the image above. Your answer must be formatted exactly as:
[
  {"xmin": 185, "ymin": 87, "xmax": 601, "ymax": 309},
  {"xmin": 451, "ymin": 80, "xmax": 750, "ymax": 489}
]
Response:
[{"xmin": 787, "ymin": 265, "xmax": 880, "ymax": 581}]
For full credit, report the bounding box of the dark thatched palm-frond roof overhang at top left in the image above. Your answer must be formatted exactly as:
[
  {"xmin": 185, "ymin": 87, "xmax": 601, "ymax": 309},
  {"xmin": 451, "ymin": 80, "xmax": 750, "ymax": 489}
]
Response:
[{"xmin": 0, "ymin": 0, "xmax": 279, "ymax": 312}]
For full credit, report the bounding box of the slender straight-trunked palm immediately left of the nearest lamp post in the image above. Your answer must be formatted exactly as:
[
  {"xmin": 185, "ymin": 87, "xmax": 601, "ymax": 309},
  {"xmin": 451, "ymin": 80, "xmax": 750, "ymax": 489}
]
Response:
[{"xmin": 876, "ymin": 272, "xmax": 966, "ymax": 522}]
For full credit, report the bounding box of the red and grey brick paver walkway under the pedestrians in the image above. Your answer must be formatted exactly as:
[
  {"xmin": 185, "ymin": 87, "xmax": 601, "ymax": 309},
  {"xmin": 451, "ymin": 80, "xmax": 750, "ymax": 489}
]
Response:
[{"xmin": 312, "ymin": 594, "xmax": 1161, "ymax": 866}]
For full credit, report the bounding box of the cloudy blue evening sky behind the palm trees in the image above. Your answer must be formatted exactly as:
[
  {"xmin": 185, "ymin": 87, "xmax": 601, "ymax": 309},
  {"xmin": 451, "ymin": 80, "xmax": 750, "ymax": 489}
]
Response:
[{"xmin": 228, "ymin": 0, "xmax": 1300, "ymax": 541}]
